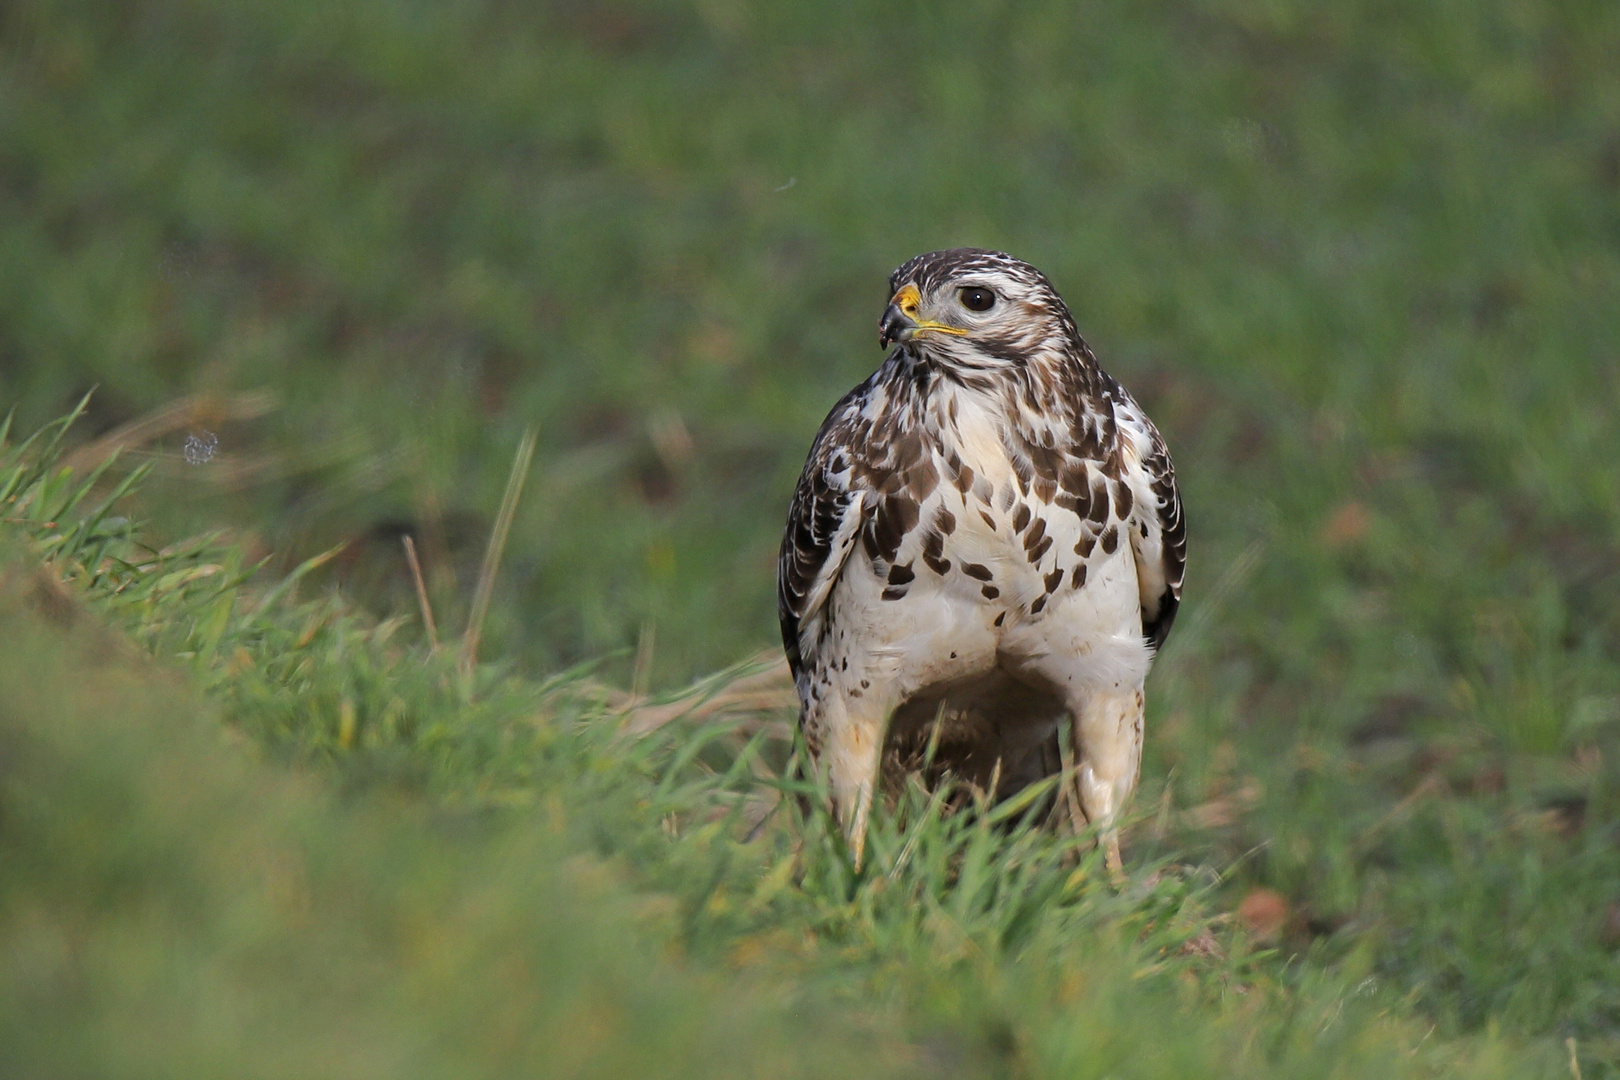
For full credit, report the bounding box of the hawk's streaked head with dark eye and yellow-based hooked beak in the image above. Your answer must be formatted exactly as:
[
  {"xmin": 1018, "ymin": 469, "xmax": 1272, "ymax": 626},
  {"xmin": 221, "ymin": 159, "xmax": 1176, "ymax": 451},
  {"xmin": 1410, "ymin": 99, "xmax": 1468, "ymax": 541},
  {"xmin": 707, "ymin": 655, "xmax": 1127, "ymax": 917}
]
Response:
[{"xmin": 878, "ymin": 248, "xmax": 1079, "ymax": 369}]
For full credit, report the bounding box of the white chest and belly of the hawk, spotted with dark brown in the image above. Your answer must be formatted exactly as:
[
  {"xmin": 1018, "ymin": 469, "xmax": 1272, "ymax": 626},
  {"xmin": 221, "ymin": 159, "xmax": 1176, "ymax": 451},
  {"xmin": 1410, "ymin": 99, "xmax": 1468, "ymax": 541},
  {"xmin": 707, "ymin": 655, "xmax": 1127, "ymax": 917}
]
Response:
[{"xmin": 807, "ymin": 383, "xmax": 1139, "ymax": 705}]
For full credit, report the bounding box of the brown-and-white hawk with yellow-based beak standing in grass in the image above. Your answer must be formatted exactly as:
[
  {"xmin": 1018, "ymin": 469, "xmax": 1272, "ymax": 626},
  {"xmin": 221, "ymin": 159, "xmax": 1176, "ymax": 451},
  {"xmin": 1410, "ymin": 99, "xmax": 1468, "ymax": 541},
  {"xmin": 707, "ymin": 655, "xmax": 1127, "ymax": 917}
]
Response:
[{"xmin": 778, "ymin": 248, "xmax": 1186, "ymax": 873}]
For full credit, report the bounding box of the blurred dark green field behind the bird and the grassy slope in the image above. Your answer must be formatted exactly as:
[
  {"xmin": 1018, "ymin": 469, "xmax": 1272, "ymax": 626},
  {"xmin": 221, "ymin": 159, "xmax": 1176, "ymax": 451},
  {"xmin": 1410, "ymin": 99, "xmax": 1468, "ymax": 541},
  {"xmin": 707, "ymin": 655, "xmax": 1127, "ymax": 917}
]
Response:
[{"xmin": 0, "ymin": 0, "xmax": 1620, "ymax": 1075}]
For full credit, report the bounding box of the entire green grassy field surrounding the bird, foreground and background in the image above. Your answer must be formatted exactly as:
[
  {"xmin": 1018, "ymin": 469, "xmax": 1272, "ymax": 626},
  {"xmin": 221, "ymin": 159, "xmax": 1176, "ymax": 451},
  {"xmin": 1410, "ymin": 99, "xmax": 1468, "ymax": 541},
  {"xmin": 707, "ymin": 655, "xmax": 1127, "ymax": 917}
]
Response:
[{"xmin": 0, "ymin": 0, "xmax": 1620, "ymax": 1077}]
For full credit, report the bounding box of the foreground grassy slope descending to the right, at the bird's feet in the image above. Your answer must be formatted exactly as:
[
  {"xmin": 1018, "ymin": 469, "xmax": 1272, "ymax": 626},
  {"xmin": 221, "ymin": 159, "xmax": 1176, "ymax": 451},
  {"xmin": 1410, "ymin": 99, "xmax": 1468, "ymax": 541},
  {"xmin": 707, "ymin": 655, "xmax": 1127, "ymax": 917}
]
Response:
[{"xmin": 0, "ymin": 399, "xmax": 1533, "ymax": 1077}]
